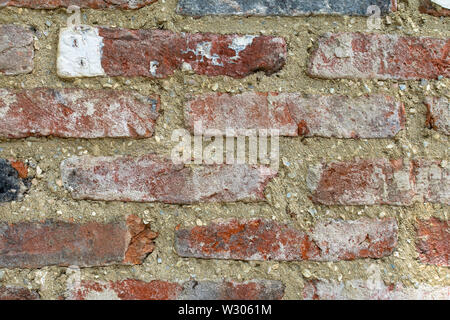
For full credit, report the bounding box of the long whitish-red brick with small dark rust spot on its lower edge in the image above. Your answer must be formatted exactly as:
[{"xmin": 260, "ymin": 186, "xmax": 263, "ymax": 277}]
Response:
[{"xmin": 184, "ymin": 92, "xmax": 405, "ymax": 138}]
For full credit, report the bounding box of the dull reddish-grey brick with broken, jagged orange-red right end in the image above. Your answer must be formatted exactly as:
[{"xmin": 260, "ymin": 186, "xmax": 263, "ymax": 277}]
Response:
[{"xmin": 0, "ymin": 216, "xmax": 157, "ymax": 268}]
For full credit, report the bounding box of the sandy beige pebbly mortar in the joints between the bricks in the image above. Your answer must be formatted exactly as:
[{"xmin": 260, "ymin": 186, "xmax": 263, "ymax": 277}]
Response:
[{"xmin": 0, "ymin": 0, "xmax": 450, "ymax": 299}]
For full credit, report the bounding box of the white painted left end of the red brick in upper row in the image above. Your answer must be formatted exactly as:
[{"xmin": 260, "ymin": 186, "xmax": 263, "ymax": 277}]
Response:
[{"xmin": 57, "ymin": 25, "xmax": 106, "ymax": 78}]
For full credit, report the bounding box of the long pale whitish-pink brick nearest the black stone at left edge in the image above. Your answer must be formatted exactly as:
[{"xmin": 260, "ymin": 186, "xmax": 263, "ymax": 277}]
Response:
[{"xmin": 61, "ymin": 154, "xmax": 276, "ymax": 204}]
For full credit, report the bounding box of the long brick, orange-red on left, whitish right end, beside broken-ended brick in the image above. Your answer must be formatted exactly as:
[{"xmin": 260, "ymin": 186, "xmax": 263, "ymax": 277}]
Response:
[{"xmin": 175, "ymin": 219, "xmax": 397, "ymax": 261}]
